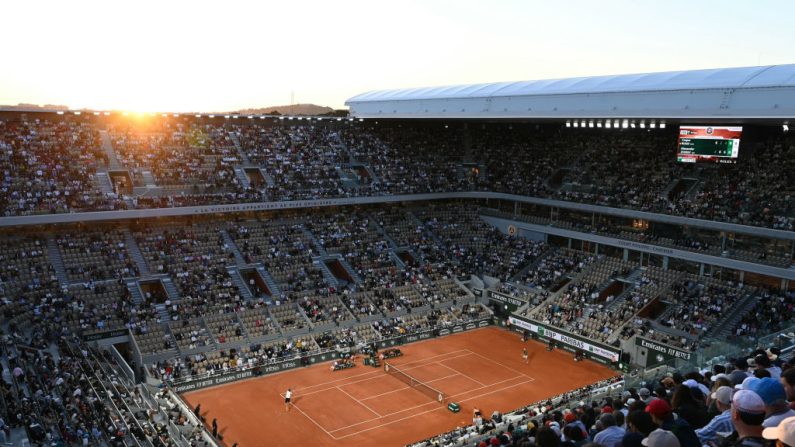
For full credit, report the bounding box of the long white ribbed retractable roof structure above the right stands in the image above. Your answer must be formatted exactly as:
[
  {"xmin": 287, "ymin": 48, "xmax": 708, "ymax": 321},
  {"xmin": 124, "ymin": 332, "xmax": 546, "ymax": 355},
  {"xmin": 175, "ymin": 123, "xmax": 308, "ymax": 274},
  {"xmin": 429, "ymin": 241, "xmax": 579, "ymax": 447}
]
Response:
[{"xmin": 345, "ymin": 64, "xmax": 795, "ymax": 120}]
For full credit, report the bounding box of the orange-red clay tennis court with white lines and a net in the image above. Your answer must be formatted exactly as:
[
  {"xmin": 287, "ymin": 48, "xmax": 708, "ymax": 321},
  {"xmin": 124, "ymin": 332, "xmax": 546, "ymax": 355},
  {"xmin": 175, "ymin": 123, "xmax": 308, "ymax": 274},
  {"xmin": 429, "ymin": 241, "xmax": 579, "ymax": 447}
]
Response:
[{"xmin": 183, "ymin": 327, "xmax": 615, "ymax": 447}]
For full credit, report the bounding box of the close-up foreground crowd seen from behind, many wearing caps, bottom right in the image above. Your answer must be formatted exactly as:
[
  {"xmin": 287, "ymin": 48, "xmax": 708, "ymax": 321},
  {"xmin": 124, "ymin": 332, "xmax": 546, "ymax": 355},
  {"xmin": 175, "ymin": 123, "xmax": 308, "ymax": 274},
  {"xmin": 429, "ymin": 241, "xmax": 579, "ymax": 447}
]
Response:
[{"xmin": 410, "ymin": 348, "xmax": 795, "ymax": 447}]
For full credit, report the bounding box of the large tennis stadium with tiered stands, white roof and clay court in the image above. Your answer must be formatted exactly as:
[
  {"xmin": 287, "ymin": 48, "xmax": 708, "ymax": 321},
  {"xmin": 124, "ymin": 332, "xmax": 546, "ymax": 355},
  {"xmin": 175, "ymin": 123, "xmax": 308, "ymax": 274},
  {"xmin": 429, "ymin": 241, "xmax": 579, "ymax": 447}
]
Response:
[{"xmin": 0, "ymin": 65, "xmax": 795, "ymax": 446}]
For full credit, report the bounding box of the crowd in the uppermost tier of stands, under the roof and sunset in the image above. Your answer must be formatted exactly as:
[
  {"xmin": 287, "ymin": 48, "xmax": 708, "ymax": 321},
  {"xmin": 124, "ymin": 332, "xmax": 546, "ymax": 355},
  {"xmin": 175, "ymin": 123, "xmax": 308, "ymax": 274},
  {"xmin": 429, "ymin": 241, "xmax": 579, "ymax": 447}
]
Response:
[{"xmin": 0, "ymin": 120, "xmax": 795, "ymax": 238}]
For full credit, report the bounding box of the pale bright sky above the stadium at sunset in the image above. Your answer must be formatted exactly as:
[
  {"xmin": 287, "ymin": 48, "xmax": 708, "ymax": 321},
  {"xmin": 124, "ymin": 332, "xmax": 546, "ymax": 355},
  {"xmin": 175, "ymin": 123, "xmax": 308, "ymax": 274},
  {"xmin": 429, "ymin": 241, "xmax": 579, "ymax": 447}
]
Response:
[{"xmin": 0, "ymin": 0, "xmax": 795, "ymax": 112}]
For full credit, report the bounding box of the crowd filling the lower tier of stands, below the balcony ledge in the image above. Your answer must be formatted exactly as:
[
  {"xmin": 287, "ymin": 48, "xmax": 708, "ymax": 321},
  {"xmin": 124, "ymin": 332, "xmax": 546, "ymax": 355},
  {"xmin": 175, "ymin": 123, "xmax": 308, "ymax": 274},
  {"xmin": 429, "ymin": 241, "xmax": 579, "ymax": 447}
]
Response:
[{"xmin": 0, "ymin": 182, "xmax": 793, "ymax": 444}]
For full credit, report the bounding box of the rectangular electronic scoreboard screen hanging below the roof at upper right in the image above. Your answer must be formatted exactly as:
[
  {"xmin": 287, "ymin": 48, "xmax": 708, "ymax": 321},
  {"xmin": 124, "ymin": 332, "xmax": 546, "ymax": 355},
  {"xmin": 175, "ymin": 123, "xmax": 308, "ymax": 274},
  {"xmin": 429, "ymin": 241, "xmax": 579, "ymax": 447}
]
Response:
[{"xmin": 676, "ymin": 126, "xmax": 743, "ymax": 163}]
